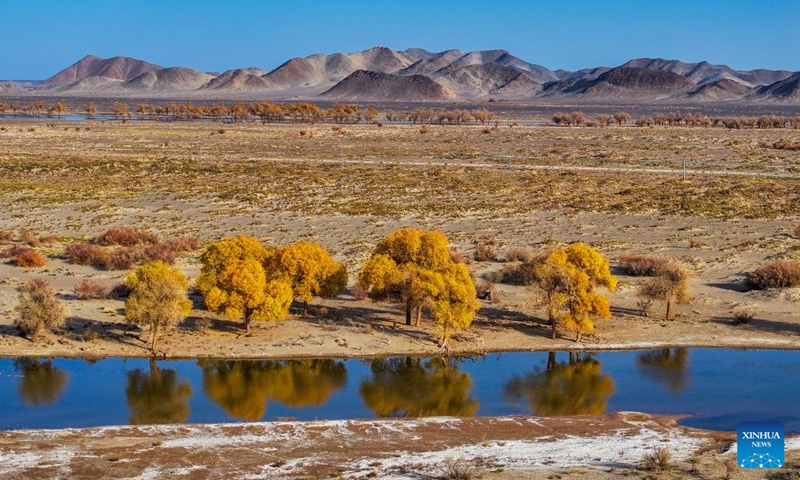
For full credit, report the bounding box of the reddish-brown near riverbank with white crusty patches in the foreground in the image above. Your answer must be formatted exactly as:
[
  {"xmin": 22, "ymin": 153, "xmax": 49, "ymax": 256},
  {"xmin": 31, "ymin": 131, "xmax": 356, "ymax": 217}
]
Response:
[{"xmin": 0, "ymin": 412, "xmax": 800, "ymax": 480}]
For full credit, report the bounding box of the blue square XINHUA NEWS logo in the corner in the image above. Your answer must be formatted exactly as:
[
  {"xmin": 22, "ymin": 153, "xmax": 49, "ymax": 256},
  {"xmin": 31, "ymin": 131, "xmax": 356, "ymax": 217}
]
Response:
[{"xmin": 737, "ymin": 422, "xmax": 784, "ymax": 468}]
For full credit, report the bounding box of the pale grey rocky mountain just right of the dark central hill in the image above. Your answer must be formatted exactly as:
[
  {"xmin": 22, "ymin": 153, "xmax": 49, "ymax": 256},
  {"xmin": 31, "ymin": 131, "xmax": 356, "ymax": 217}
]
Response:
[{"xmin": 432, "ymin": 63, "xmax": 541, "ymax": 98}]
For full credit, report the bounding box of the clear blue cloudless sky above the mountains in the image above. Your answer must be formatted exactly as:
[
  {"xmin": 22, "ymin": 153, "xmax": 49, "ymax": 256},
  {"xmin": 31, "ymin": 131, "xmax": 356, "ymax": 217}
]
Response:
[{"xmin": 0, "ymin": 0, "xmax": 800, "ymax": 80}]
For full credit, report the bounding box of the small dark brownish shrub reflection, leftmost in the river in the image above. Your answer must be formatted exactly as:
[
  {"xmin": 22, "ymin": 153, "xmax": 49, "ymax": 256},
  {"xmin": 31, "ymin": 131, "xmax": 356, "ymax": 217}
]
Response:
[{"xmin": 13, "ymin": 357, "xmax": 67, "ymax": 407}]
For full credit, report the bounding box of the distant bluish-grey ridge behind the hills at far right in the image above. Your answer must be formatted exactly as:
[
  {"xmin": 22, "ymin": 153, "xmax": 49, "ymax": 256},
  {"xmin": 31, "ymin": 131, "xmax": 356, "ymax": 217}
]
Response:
[{"xmin": 622, "ymin": 58, "xmax": 792, "ymax": 87}]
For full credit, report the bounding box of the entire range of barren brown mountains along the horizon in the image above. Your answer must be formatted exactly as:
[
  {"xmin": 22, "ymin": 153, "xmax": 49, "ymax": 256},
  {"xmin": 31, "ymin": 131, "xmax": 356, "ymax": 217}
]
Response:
[{"xmin": 0, "ymin": 46, "xmax": 800, "ymax": 103}]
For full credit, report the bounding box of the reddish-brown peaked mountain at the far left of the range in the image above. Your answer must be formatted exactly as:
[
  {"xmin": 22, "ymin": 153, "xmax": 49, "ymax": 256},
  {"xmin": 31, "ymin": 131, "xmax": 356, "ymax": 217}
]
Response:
[{"xmin": 44, "ymin": 55, "xmax": 163, "ymax": 86}]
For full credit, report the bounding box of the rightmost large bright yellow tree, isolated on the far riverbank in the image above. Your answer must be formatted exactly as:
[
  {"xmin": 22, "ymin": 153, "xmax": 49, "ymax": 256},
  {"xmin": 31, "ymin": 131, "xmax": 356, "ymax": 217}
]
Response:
[{"xmin": 534, "ymin": 243, "xmax": 617, "ymax": 342}]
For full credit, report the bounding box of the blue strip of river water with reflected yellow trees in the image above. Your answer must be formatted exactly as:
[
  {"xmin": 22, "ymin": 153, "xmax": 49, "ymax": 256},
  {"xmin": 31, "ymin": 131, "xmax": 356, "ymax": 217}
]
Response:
[{"xmin": 0, "ymin": 349, "xmax": 800, "ymax": 432}]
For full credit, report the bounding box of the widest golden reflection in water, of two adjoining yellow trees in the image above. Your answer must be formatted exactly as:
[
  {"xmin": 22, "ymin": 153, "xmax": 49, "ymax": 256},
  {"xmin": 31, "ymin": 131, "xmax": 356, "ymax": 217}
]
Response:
[{"xmin": 198, "ymin": 359, "xmax": 347, "ymax": 421}]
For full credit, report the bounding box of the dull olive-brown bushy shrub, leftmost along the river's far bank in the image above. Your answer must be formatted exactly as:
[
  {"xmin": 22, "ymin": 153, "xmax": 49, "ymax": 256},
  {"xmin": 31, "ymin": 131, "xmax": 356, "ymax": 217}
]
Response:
[{"xmin": 14, "ymin": 279, "xmax": 66, "ymax": 336}]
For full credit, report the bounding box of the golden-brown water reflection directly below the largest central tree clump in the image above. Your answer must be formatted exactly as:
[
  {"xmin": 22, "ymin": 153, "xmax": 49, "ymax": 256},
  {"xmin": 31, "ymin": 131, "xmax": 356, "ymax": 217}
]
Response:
[{"xmin": 359, "ymin": 357, "xmax": 479, "ymax": 417}]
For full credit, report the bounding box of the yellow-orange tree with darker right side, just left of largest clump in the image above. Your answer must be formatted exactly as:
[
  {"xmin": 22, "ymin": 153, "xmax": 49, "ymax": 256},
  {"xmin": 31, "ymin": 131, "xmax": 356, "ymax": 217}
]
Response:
[{"xmin": 267, "ymin": 242, "xmax": 347, "ymax": 315}]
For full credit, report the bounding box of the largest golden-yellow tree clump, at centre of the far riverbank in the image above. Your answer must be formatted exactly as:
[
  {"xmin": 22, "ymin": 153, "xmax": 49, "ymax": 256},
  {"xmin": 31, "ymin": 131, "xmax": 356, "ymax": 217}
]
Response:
[{"xmin": 359, "ymin": 228, "xmax": 480, "ymax": 346}]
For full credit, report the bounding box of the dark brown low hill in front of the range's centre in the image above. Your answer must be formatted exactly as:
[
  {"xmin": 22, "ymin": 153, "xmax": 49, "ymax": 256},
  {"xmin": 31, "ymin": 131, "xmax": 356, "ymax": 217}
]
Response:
[{"xmin": 319, "ymin": 70, "xmax": 456, "ymax": 102}]
